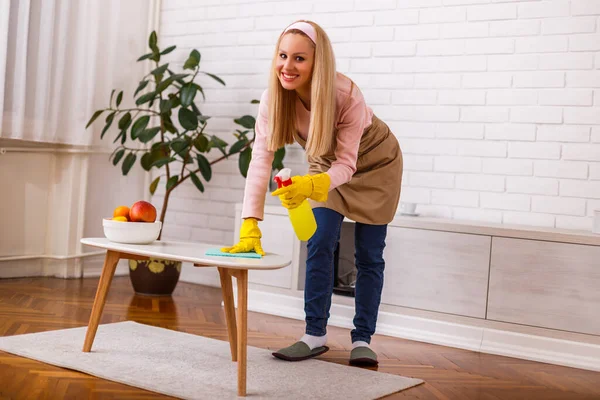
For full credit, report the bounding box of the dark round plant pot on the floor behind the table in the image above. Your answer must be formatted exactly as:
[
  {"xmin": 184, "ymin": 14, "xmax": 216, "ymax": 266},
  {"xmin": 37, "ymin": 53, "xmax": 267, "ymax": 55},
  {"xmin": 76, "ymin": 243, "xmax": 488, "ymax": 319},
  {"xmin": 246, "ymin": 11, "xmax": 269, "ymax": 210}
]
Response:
[{"xmin": 129, "ymin": 258, "xmax": 181, "ymax": 296}]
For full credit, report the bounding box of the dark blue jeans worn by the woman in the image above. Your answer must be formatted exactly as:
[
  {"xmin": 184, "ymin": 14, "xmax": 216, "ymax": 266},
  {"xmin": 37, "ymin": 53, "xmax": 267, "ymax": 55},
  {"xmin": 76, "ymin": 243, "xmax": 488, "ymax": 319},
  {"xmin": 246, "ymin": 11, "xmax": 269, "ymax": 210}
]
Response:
[{"xmin": 304, "ymin": 207, "xmax": 387, "ymax": 343}]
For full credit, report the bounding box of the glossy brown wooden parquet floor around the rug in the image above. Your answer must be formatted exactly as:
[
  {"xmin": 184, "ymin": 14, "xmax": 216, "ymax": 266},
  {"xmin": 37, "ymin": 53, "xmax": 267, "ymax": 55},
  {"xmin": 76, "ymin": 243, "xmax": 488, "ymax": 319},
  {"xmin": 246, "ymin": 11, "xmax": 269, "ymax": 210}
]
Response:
[{"xmin": 0, "ymin": 277, "xmax": 600, "ymax": 400}]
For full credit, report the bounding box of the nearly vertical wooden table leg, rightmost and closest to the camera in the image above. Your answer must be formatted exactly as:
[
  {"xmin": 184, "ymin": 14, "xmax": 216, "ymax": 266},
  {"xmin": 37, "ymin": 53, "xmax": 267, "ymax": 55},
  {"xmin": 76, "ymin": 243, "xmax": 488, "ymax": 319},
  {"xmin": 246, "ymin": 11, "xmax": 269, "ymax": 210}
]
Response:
[{"xmin": 235, "ymin": 269, "xmax": 248, "ymax": 396}]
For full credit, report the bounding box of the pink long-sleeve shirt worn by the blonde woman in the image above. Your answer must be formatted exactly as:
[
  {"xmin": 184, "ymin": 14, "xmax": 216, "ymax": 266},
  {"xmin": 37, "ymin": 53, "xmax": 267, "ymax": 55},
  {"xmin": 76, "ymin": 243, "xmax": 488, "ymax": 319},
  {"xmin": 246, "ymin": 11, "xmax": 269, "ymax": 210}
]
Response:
[{"xmin": 242, "ymin": 73, "xmax": 373, "ymax": 220}]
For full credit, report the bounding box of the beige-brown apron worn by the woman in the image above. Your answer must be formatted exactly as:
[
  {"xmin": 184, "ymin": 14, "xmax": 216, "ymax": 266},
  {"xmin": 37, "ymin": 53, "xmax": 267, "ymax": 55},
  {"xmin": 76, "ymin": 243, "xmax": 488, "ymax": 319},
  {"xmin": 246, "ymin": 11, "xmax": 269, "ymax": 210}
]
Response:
[{"xmin": 294, "ymin": 115, "xmax": 403, "ymax": 225}]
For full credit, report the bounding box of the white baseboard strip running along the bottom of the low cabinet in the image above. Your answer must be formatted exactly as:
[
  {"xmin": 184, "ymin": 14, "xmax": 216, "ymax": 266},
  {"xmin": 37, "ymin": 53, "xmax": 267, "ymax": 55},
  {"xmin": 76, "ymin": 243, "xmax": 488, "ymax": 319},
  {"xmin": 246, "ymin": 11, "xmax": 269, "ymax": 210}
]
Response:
[{"xmin": 248, "ymin": 290, "xmax": 600, "ymax": 371}]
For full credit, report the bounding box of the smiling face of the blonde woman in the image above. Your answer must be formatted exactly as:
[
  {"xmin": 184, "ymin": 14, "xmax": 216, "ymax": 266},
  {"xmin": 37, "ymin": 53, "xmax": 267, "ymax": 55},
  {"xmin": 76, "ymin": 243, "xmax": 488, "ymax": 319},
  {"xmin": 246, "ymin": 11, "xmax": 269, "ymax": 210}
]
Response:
[{"xmin": 275, "ymin": 33, "xmax": 315, "ymax": 90}]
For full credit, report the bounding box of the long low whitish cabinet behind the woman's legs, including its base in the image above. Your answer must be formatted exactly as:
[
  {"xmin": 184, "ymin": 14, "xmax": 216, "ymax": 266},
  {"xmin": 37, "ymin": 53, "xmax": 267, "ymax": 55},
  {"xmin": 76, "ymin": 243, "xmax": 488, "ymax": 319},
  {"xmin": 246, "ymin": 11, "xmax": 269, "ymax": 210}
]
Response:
[{"xmin": 236, "ymin": 205, "xmax": 600, "ymax": 370}]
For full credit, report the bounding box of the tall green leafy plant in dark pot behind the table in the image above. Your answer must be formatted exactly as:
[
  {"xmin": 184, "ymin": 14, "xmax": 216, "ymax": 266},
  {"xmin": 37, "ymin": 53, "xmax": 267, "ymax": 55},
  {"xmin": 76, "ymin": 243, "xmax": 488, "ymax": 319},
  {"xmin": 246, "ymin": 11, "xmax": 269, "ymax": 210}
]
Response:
[{"xmin": 86, "ymin": 31, "xmax": 285, "ymax": 295}]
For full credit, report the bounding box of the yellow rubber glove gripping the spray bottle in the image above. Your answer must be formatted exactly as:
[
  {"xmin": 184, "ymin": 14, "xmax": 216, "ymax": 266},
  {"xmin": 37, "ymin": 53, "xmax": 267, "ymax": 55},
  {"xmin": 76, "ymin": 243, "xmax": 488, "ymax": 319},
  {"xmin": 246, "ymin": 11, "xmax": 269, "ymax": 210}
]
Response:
[{"xmin": 271, "ymin": 172, "xmax": 331, "ymax": 209}]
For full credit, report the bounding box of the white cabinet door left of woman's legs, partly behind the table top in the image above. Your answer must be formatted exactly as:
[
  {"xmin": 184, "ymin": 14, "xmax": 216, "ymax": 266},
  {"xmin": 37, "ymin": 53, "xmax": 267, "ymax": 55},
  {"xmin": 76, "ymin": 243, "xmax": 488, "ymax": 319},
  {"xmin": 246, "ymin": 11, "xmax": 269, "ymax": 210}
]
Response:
[{"xmin": 248, "ymin": 214, "xmax": 298, "ymax": 289}]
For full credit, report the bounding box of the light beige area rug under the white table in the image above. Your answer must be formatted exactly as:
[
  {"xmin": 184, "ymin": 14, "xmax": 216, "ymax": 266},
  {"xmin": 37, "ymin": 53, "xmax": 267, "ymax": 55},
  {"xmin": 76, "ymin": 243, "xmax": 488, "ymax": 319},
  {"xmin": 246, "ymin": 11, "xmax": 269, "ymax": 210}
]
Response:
[{"xmin": 0, "ymin": 321, "xmax": 422, "ymax": 400}]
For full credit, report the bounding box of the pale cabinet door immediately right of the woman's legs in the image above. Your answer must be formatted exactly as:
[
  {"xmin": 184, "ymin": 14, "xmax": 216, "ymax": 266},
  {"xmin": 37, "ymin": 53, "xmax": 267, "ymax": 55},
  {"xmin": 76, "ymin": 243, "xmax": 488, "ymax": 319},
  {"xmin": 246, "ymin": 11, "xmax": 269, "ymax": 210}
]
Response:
[{"xmin": 382, "ymin": 226, "xmax": 491, "ymax": 318}]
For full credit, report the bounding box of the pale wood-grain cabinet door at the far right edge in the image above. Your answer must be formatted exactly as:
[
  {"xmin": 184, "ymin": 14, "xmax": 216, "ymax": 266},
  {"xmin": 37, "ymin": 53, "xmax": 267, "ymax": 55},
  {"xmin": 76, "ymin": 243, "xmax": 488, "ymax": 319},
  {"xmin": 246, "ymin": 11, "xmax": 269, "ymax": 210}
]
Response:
[{"xmin": 487, "ymin": 237, "xmax": 600, "ymax": 335}]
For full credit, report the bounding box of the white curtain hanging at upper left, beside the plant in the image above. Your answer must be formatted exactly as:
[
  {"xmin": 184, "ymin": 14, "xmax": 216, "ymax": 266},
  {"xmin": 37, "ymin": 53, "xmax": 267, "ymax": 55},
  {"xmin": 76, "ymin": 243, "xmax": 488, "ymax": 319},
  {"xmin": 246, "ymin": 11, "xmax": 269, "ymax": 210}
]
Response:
[{"xmin": 0, "ymin": 0, "xmax": 152, "ymax": 145}]
